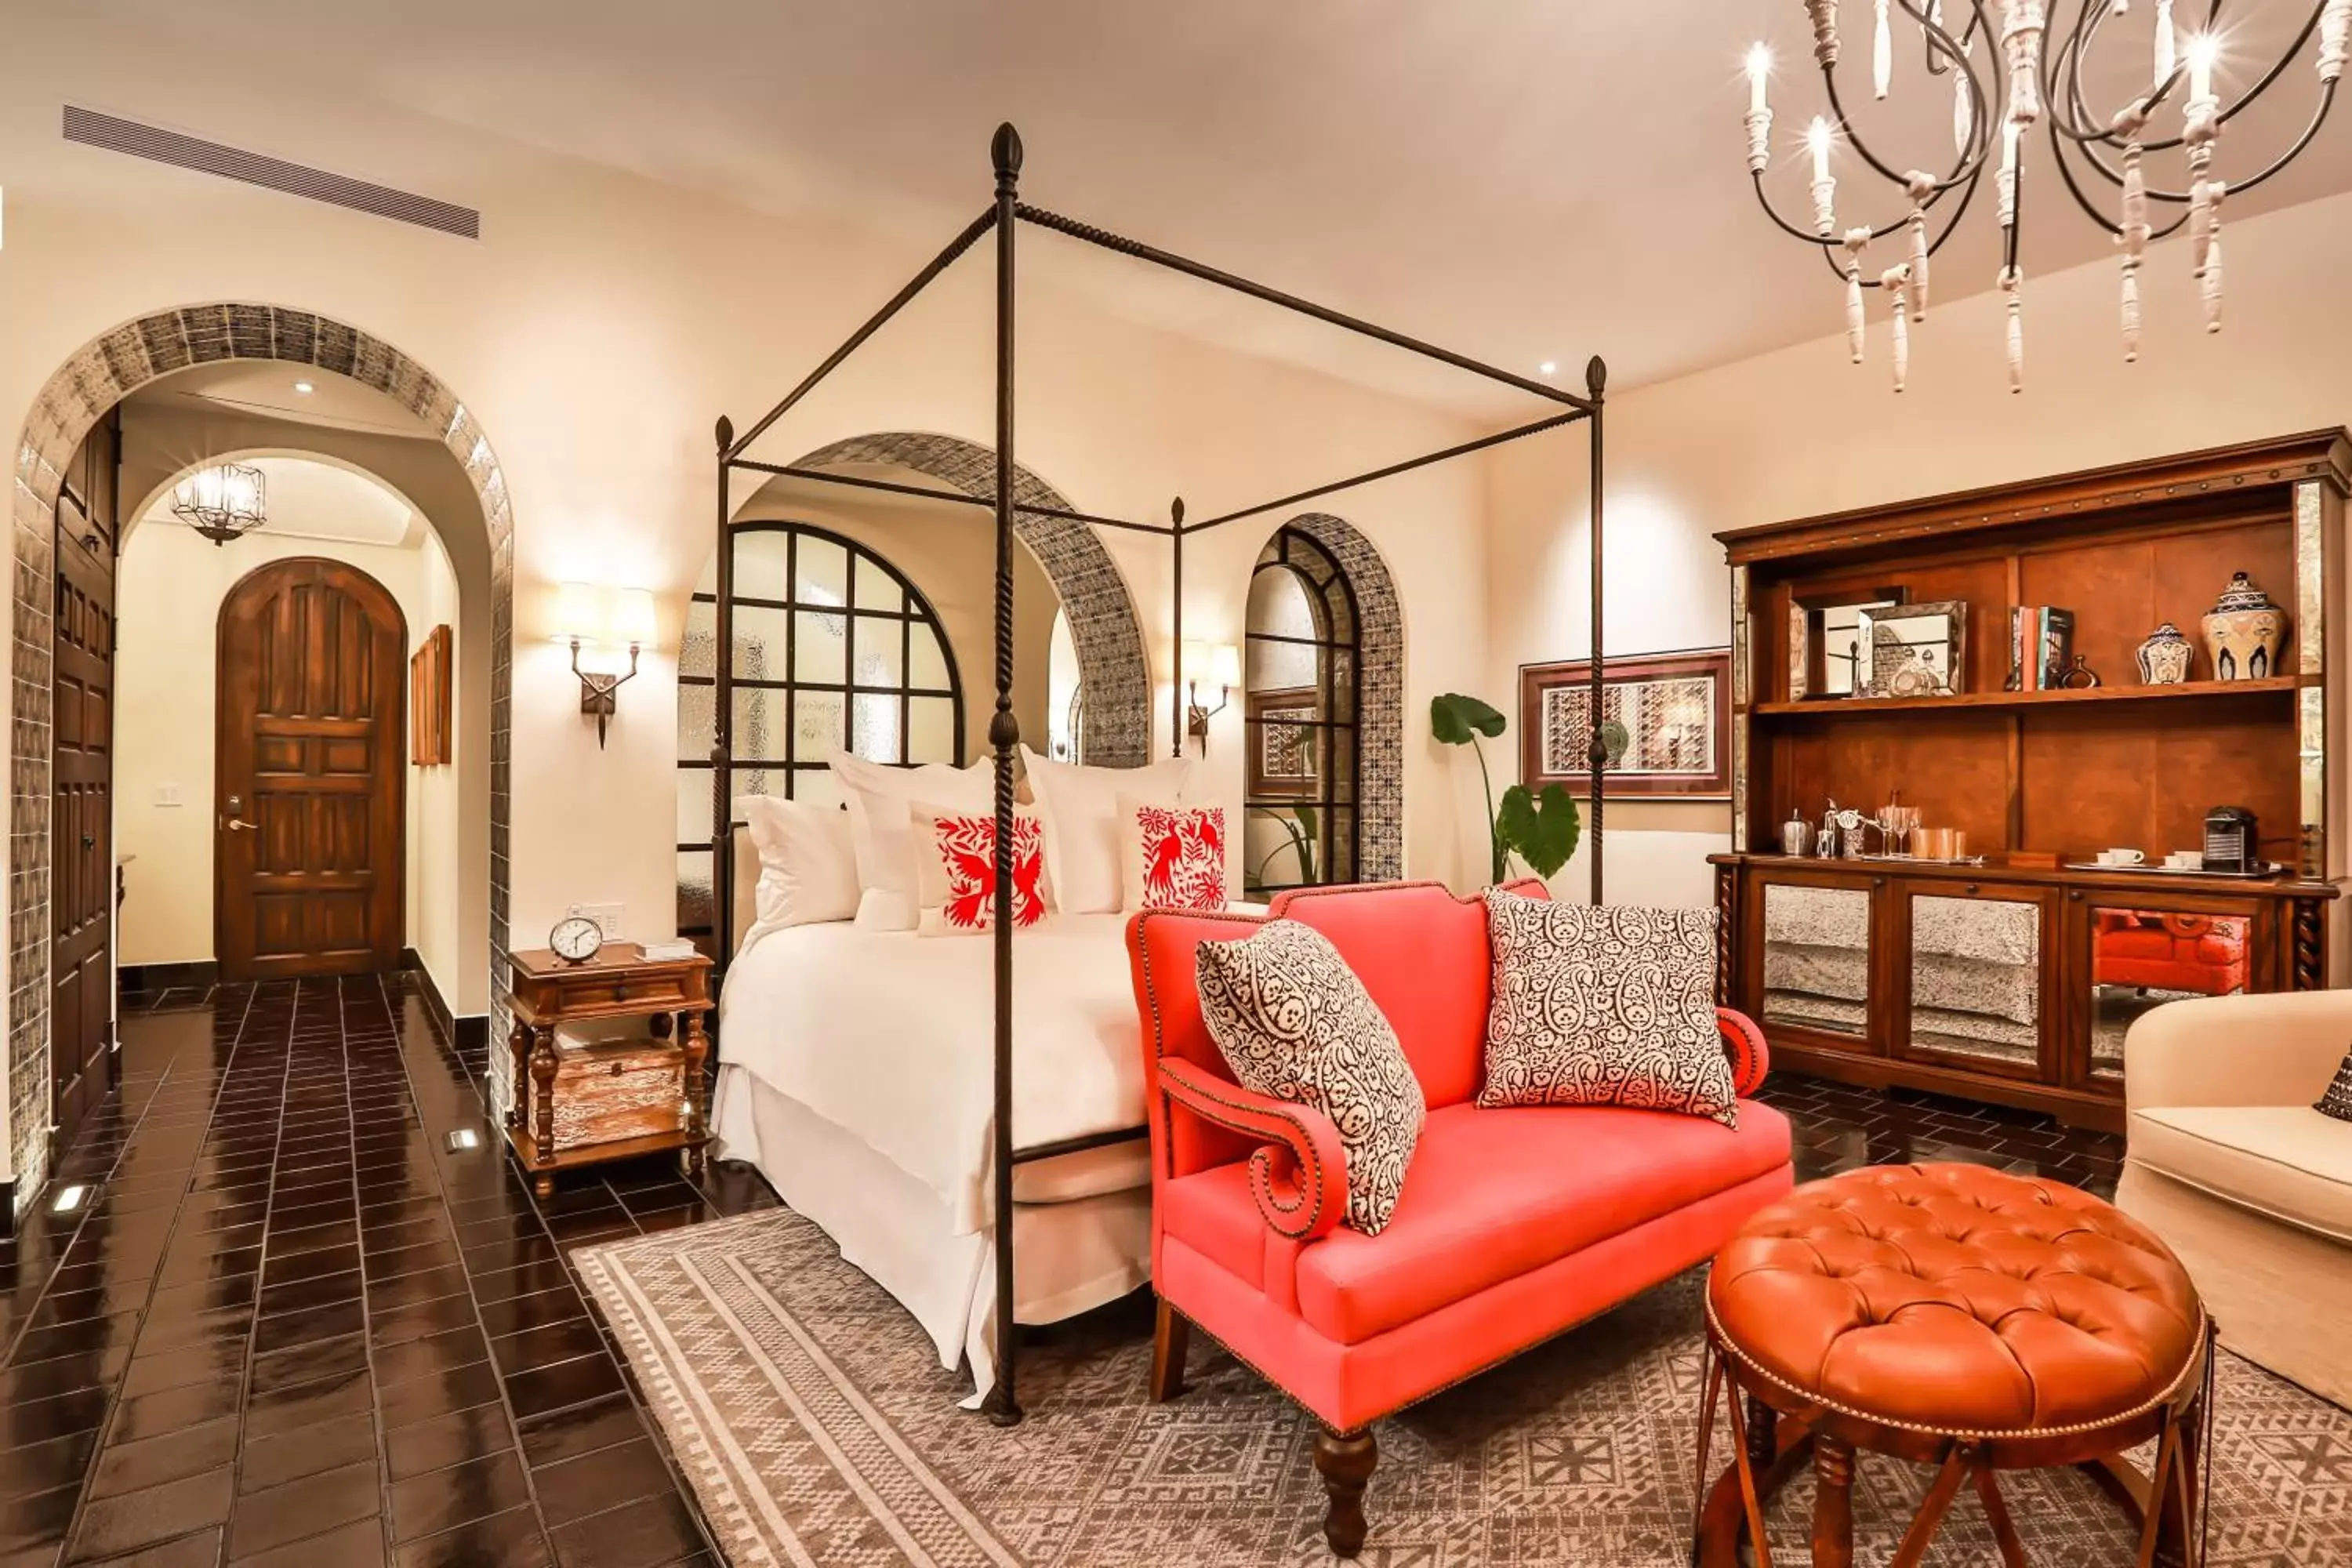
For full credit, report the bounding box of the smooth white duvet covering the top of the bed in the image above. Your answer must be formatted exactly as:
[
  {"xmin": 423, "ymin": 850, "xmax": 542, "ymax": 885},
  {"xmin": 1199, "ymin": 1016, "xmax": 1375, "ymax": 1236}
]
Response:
[{"xmin": 720, "ymin": 914, "xmax": 1143, "ymax": 1234}]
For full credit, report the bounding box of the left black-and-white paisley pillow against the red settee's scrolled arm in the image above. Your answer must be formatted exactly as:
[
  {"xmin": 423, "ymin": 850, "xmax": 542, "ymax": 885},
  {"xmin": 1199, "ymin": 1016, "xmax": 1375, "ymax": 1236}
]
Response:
[{"xmin": 1195, "ymin": 919, "xmax": 1423, "ymax": 1236}]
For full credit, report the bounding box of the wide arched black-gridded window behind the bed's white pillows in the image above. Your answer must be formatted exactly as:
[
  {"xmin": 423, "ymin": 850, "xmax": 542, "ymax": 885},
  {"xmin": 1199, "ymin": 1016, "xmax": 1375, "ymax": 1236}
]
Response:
[{"xmin": 677, "ymin": 522, "xmax": 964, "ymax": 935}]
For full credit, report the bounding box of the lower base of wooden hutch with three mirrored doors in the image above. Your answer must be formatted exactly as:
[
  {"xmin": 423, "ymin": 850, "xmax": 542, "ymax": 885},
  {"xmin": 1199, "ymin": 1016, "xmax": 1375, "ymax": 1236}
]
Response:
[{"xmin": 1715, "ymin": 853, "xmax": 2338, "ymax": 1131}]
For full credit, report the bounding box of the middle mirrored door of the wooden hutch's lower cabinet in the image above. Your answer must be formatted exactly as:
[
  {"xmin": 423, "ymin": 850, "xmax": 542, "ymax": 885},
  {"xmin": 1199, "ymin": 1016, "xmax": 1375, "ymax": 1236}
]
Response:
[{"xmin": 1903, "ymin": 888, "xmax": 2049, "ymax": 1072}]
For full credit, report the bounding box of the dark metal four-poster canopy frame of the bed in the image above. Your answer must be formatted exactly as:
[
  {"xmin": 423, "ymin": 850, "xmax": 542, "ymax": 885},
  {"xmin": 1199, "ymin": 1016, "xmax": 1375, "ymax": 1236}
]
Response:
[{"xmin": 710, "ymin": 125, "xmax": 1609, "ymax": 1427}]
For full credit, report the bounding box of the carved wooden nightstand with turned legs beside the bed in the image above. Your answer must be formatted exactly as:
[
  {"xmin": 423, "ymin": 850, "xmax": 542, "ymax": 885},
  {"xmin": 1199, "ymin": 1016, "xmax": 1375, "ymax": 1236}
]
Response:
[{"xmin": 506, "ymin": 942, "xmax": 710, "ymax": 1196}]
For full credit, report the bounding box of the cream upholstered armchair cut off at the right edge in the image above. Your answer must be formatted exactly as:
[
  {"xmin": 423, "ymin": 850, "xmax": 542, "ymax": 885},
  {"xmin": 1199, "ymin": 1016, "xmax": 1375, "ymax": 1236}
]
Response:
[{"xmin": 2117, "ymin": 992, "xmax": 2352, "ymax": 1406}]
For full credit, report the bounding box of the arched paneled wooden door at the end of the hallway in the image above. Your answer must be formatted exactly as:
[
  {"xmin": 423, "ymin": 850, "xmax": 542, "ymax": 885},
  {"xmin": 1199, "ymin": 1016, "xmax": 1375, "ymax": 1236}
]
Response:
[{"xmin": 214, "ymin": 564, "xmax": 407, "ymax": 980}]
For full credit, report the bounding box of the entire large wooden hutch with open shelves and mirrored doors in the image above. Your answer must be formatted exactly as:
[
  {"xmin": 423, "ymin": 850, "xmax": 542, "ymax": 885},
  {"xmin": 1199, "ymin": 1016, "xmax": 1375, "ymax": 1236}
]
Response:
[{"xmin": 1715, "ymin": 430, "xmax": 2352, "ymax": 1128}]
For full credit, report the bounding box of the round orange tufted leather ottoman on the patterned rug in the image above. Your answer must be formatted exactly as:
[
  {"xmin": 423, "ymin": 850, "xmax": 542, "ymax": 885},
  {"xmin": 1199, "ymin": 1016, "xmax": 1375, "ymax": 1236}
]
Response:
[{"xmin": 1693, "ymin": 1163, "xmax": 2213, "ymax": 1568}]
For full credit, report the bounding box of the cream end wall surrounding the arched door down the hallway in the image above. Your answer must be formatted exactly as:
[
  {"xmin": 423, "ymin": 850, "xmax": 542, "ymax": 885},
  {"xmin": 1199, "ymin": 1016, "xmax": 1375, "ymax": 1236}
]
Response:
[{"xmin": 115, "ymin": 522, "xmax": 428, "ymax": 964}]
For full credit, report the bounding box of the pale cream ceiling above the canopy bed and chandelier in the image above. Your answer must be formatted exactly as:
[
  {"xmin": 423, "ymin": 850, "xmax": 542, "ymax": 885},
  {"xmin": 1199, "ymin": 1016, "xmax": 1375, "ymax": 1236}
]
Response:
[{"xmin": 64, "ymin": 0, "xmax": 2352, "ymax": 411}]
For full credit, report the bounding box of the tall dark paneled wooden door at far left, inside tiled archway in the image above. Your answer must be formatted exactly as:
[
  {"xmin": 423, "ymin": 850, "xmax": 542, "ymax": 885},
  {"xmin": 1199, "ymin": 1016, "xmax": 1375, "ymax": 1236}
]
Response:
[{"xmin": 49, "ymin": 416, "xmax": 122, "ymax": 1149}]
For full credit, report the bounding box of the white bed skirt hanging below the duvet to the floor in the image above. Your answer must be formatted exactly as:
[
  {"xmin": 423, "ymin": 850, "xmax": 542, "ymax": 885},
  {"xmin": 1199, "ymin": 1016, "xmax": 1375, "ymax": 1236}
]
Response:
[{"xmin": 713, "ymin": 1062, "xmax": 1152, "ymax": 1403}]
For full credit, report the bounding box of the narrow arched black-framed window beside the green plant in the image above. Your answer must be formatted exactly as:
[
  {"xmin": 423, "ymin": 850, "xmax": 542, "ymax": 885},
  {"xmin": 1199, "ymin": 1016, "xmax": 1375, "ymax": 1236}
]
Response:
[{"xmin": 1242, "ymin": 527, "xmax": 1362, "ymax": 898}]
